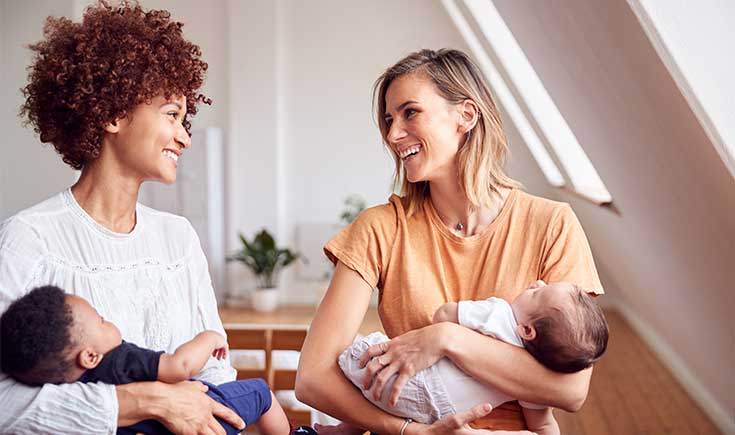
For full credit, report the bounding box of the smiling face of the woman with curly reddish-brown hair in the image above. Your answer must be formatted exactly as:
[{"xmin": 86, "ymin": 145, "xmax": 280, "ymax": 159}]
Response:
[{"xmin": 108, "ymin": 96, "xmax": 191, "ymax": 184}]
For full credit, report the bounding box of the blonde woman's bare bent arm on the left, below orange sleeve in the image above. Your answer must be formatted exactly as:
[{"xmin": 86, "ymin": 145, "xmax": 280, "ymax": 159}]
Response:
[{"xmin": 296, "ymin": 262, "xmax": 403, "ymax": 434}]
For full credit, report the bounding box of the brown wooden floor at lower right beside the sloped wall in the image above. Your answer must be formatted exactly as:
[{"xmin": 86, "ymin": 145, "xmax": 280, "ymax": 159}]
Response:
[{"xmin": 554, "ymin": 311, "xmax": 720, "ymax": 435}]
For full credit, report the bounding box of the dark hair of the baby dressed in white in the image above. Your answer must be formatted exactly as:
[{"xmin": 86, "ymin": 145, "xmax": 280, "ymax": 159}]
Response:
[{"xmin": 524, "ymin": 286, "xmax": 608, "ymax": 373}]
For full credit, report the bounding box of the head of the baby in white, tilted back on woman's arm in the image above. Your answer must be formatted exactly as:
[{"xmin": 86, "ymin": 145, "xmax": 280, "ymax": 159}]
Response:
[{"xmin": 511, "ymin": 282, "xmax": 608, "ymax": 373}]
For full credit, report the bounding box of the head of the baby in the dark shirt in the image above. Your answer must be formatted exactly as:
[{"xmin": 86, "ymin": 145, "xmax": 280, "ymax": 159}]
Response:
[{"xmin": 0, "ymin": 286, "xmax": 122, "ymax": 385}]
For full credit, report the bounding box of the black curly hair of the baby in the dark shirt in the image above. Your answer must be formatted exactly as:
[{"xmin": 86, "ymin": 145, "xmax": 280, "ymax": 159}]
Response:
[{"xmin": 0, "ymin": 286, "xmax": 74, "ymax": 385}]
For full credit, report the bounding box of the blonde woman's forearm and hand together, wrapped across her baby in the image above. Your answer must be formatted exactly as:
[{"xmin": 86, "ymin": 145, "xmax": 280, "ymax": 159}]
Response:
[{"xmin": 360, "ymin": 322, "xmax": 592, "ymax": 412}]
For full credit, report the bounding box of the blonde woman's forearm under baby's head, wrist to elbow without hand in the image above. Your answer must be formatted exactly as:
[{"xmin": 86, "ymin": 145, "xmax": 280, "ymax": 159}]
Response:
[{"xmin": 440, "ymin": 323, "xmax": 592, "ymax": 412}]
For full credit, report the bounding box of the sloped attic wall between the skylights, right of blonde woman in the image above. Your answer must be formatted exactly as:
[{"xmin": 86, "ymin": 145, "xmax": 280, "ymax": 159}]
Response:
[{"xmin": 495, "ymin": 0, "xmax": 735, "ymax": 430}]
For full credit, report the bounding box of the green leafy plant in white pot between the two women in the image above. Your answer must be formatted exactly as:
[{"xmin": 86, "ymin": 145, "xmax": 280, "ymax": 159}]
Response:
[{"xmin": 227, "ymin": 229, "xmax": 299, "ymax": 312}]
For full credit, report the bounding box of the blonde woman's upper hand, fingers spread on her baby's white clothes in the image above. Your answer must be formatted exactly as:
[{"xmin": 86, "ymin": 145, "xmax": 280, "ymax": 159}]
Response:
[{"xmin": 360, "ymin": 323, "xmax": 447, "ymax": 406}]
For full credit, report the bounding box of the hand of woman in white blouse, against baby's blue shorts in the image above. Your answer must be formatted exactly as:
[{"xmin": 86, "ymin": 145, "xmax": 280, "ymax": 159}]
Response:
[{"xmin": 158, "ymin": 381, "xmax": 245, "ymax": 435}]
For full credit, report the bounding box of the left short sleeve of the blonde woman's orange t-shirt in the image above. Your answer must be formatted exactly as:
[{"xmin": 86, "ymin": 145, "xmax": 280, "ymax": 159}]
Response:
[{"xmin": 324, "ymin": 204, "xmax": 397, "ymax": 288}]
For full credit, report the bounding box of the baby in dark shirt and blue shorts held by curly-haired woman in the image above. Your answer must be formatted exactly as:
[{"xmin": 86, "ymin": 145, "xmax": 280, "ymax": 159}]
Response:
[{"xmin": 0, "ymin": 286, "xmax": 289, "ymax": 435}]
